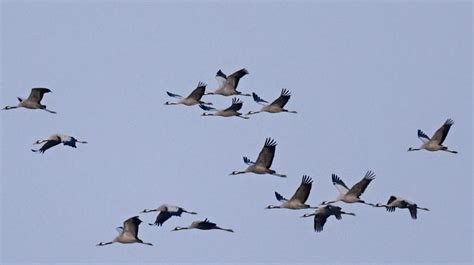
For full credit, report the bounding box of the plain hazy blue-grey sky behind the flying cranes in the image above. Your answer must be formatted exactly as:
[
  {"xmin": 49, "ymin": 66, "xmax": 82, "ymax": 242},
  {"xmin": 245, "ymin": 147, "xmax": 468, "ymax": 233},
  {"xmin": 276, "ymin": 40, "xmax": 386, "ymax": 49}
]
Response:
[{"xmin": 0, "ymin": 1, "xmax": 473, "ymax": 264}]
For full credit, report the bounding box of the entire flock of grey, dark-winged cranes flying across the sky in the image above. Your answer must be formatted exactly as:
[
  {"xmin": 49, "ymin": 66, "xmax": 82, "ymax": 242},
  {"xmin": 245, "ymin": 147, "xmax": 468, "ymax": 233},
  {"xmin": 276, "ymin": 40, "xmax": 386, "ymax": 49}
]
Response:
[{"xmin": 3, "ymin": 66, "xmax": 457, "ymax": 246}]
